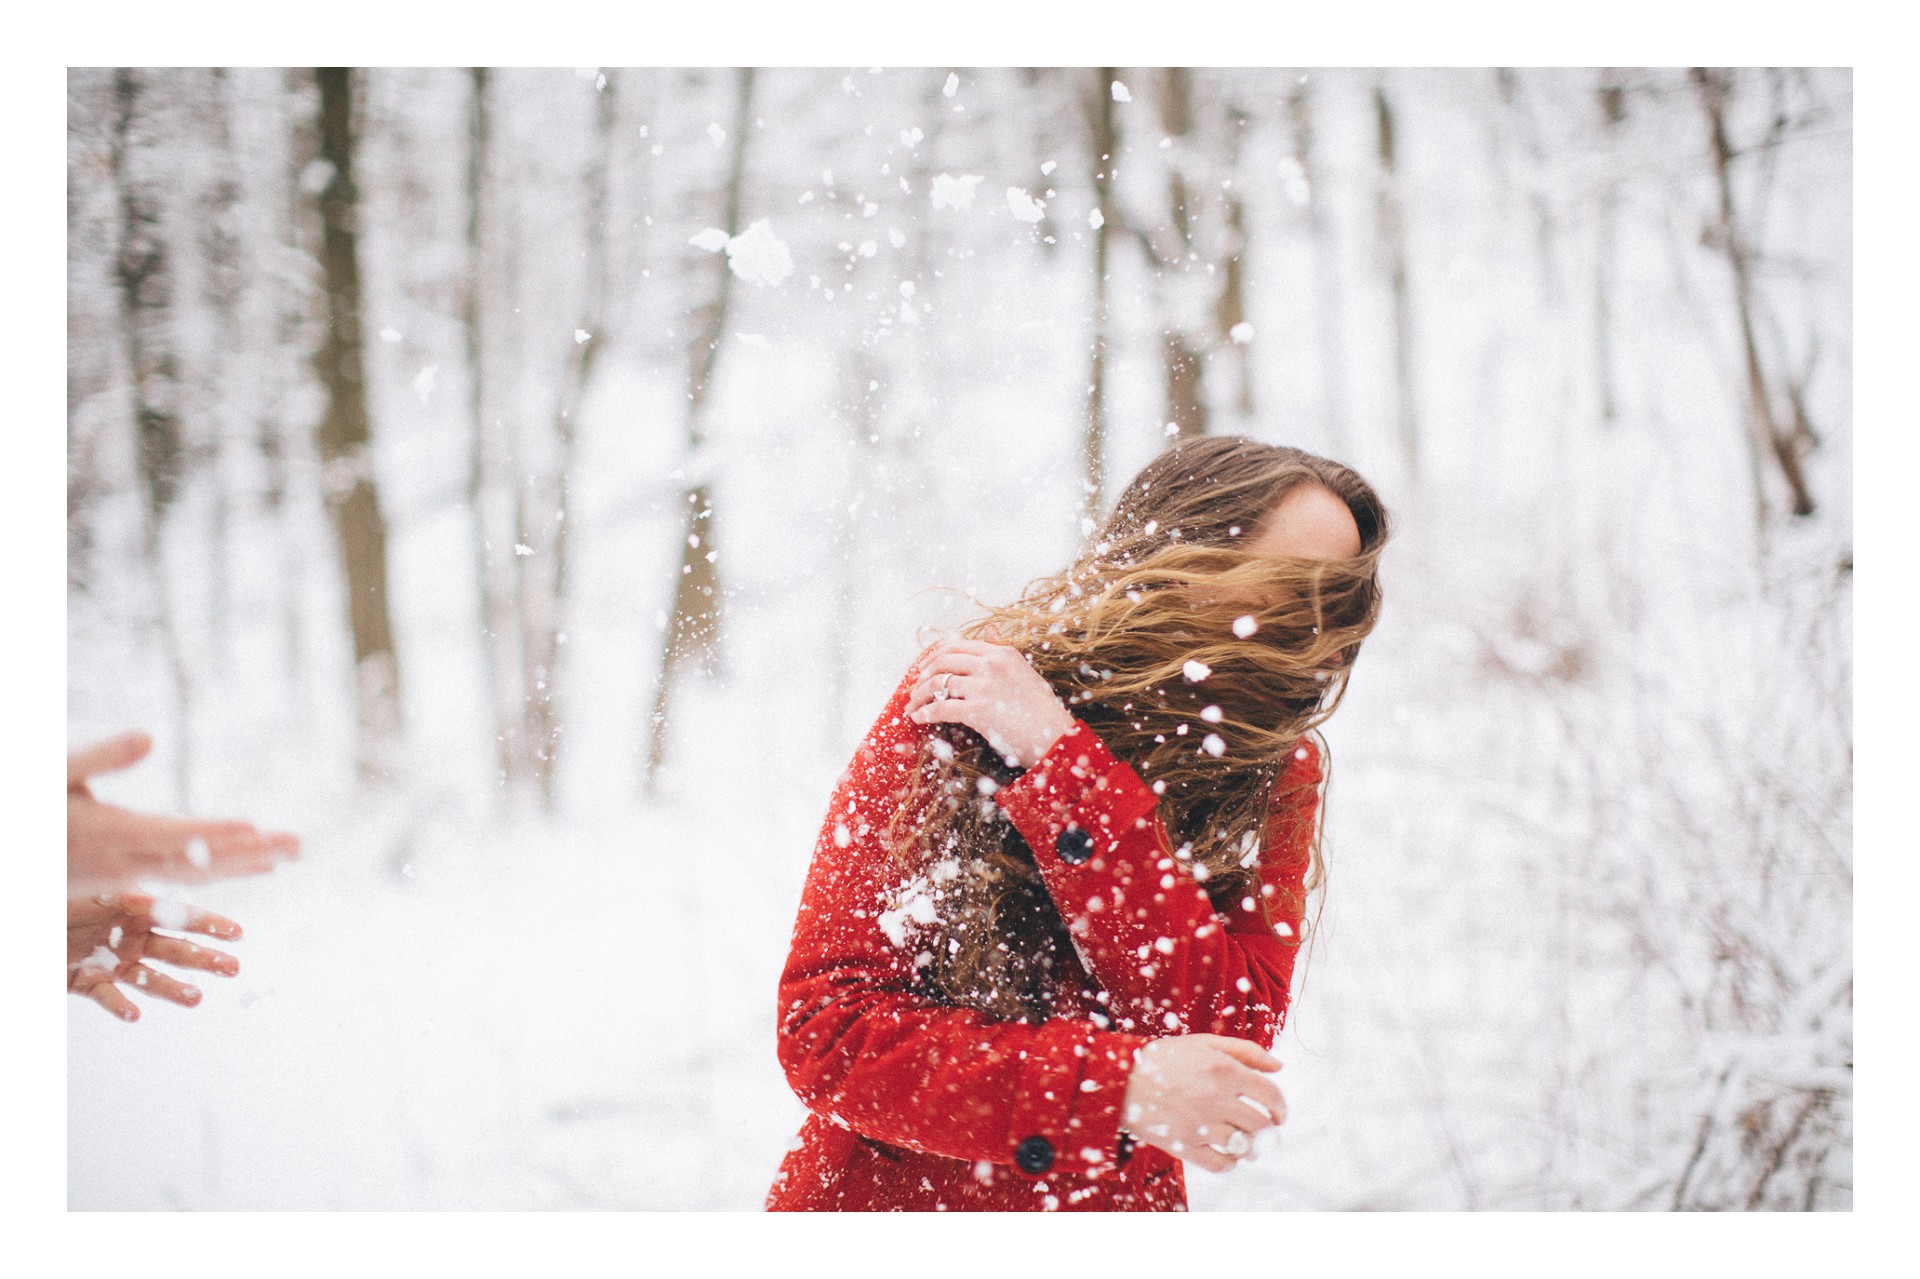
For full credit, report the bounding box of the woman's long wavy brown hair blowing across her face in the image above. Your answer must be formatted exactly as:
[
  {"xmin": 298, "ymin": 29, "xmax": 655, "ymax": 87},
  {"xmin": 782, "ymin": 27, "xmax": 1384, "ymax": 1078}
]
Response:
[{"xmin": 889, "ymin": 436, "xmax": 1388, "ymax": 1020}]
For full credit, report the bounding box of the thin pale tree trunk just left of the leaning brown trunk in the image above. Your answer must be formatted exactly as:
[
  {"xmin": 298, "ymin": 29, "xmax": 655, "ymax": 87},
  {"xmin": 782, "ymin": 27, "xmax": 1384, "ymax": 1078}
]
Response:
[{"xmin": 520, "ymin": 79, "xmax": 614, "ymax": 812}]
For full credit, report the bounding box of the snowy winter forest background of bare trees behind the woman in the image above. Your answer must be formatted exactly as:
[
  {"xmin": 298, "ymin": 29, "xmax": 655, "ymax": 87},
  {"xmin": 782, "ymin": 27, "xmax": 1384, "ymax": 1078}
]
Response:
[{"xmin": 67, "ymin": 69, "xmax": 1853, "ymax": 1210}]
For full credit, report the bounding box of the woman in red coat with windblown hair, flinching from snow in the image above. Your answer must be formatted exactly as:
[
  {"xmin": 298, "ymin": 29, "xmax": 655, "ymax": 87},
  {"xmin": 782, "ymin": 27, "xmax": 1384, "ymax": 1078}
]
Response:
[{"xmin": 768, "ymin": 438, "xmax": 1386, "ymax": 1210}]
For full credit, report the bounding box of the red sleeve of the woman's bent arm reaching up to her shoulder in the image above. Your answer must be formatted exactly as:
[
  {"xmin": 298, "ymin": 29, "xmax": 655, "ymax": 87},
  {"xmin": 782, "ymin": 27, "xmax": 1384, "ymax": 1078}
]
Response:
[{"xmin": 996, "ymin": 720, "xmax": 1323, "ymax": 1049}]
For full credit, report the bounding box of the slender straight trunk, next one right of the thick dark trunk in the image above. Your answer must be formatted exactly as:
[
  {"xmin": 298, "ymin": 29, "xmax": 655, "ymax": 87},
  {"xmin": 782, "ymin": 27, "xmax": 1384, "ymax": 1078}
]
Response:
[{"xmin": 461, "ymin": 67, "xmax": 524, "ymax": 801}]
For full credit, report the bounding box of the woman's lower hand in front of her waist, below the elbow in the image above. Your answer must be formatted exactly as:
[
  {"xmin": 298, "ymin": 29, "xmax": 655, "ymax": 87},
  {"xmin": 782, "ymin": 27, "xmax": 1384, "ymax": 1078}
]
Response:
[{"xmin": 1121, "ymin": 1035, "xmax": 1286, "ymax": 1171}]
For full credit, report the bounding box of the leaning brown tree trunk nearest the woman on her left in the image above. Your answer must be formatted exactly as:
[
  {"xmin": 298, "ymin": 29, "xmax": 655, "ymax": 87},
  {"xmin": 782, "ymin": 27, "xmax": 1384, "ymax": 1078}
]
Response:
[{"xmin": 645, "ymin": 67, "xmax": 755, "ymax": 791}]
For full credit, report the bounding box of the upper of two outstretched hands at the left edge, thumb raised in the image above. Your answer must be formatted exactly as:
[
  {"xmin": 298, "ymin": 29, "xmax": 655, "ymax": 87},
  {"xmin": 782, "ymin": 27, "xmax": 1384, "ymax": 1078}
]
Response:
[{"xmin": 67, "ymin": 732, "xmax": 300, "ymax": 889}]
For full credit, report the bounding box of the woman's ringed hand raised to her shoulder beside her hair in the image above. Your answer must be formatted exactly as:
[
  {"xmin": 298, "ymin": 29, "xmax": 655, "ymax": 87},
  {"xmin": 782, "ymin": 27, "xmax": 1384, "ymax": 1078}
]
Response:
[{"xmin": 906, "ymin": 630, "xmax": 1073, "ymax": 768}]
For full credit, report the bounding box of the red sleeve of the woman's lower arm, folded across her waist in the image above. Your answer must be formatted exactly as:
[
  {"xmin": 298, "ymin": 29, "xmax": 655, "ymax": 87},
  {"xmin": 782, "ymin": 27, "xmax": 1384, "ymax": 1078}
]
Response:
[{"xmin": 780, "ymin": 666, "xmax": 1146, "ymax": 1177}]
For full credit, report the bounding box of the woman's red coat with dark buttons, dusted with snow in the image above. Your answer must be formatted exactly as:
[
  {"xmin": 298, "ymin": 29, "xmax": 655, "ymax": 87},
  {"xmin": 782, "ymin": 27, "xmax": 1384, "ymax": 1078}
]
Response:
[{"xmin": 766, "ymin": 649, "xmax": 1321, "ymax": 1210}]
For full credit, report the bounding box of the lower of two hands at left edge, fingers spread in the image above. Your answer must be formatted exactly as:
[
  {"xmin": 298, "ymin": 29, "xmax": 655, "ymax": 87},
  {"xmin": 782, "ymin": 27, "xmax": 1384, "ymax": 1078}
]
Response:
[{"xmin": 67, "ymin": 893, "xmax": 240, "ymax": 1022}]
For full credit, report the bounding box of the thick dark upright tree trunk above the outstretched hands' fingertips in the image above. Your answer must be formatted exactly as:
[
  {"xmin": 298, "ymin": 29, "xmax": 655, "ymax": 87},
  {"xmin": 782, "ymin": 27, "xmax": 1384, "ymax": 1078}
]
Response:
[{"xmin": 317, "ymin": 67, "xmax": 401, "ymax": 780}]
